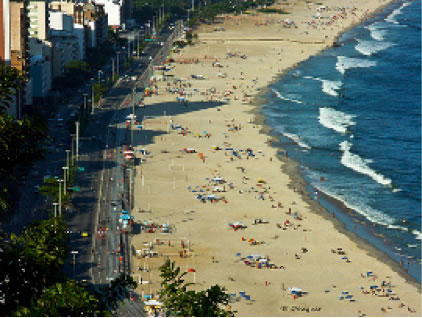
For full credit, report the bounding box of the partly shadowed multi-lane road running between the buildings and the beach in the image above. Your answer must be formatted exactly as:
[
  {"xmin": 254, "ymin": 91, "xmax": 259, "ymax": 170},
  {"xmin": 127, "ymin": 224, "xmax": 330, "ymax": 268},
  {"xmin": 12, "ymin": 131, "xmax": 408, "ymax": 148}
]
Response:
[{"xmin": 3, "ymin": 19, "xmax": 183, "ymax": 316}]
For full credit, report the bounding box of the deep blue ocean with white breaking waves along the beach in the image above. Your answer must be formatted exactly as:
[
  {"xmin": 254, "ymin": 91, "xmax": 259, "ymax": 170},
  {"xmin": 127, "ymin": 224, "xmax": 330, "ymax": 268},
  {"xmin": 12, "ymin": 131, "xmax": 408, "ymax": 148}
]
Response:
[{"xmin": 262, "ymin": 0, "xmax": 422, "ymax": 281}]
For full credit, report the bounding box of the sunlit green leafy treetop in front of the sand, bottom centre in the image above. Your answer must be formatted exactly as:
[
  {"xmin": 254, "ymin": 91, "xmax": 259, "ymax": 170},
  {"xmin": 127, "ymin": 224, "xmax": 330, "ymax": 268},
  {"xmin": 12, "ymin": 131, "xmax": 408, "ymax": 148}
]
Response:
[{"xmin": 159, "ymin": 260, "xmax": 234, "ymax": 317}]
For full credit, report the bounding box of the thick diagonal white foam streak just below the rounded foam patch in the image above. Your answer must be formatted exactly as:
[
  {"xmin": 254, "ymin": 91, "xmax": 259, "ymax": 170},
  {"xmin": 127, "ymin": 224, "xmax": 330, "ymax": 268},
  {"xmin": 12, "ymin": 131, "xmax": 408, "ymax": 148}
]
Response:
[{"xmin": 340, "ymin": 141, "xmax": 391, "ymax": 186}]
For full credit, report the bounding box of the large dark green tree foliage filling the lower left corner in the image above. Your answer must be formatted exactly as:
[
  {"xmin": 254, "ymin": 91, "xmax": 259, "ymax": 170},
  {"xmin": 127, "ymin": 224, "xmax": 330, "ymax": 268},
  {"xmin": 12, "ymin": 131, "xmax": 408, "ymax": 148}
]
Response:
[{"xmin": 0, "ymin": 219, "xmax": 67, "ymax": 315}]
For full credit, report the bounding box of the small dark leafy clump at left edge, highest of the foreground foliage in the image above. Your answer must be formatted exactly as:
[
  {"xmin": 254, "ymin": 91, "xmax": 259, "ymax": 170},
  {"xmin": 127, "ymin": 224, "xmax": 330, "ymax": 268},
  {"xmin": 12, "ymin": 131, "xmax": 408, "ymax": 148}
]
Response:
[{"xmin": 0, "ymin": 63, "xmax": 24, "ymax": 112}]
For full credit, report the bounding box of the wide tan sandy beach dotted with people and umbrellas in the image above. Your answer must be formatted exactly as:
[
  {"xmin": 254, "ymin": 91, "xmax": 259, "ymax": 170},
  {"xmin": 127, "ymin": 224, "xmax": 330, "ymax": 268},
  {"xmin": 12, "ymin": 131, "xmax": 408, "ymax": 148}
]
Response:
[{"xmin": 132, "ymin": 0, "xmax": 421, "ymax": 317}]
